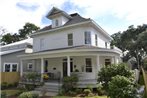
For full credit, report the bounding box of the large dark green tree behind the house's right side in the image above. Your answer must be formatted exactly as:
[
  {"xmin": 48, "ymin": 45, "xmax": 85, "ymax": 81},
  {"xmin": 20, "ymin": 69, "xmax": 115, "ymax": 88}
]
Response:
[{"xmin": 111, "ymin": 24, "xmax": 147, "ymax": 66}]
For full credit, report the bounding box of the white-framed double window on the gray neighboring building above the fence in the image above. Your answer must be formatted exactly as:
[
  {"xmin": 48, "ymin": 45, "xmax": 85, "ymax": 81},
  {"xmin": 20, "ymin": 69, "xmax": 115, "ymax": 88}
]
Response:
[{"xmin": 4, "ymin": 63, "xmax": 18, "ymax": 72}]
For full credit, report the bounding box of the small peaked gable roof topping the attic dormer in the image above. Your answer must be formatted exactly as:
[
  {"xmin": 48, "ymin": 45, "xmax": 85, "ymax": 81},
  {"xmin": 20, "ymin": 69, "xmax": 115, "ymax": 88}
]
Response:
[{"xmin": 46, "ymin": 7, "xmax": 71, "ymax": 19}]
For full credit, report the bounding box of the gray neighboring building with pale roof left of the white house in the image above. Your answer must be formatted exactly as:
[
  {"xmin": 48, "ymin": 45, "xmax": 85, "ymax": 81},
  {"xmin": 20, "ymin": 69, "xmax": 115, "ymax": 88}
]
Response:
[{"xmin": 0, "ymin": 38, "xmax": 33, "ymax": 72}]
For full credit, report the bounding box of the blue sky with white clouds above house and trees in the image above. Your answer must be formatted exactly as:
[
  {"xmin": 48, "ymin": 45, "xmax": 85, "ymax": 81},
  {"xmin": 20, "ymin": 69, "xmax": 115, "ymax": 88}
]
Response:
[{"xmin": 0, "ymin": 0, "xmax": 147, "ymax": 35}]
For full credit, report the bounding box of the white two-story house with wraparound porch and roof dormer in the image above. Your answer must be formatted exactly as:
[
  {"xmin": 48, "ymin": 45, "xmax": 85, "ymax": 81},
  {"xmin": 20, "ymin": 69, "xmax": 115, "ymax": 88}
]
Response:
[{"xmin": 19, "ymin": 7, "xmax": 121, "ymax": 86}]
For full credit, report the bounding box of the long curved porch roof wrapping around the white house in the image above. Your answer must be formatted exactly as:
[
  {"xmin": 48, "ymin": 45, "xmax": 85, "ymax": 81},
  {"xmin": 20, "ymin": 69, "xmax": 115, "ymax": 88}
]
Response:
[{"xmin": 18, "ymin": 45, "xmax": 121, "ymax": 57}]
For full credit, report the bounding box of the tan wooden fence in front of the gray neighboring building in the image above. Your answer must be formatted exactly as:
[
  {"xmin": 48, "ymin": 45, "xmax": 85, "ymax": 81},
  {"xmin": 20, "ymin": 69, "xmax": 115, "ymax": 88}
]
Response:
[{"xmin": 0, "ymin": 72, "xmax": 20, "ymax": 83}]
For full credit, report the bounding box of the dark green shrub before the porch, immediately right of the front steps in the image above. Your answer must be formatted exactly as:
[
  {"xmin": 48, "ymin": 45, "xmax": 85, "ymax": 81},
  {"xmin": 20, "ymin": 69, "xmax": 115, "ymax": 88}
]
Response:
[{"xmin": 62, "ymin": 75, "xmax": 78, "ymax": 93}]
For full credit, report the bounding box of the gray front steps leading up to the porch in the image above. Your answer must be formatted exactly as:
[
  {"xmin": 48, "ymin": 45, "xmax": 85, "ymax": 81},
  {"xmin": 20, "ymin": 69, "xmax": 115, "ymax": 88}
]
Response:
[{"xmin": 35, "ymin": 83, "xmax": 62, "ymax": 94}]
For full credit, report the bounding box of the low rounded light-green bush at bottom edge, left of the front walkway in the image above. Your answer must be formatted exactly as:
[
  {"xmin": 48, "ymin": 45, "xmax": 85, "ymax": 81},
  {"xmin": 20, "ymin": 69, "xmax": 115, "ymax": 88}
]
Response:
[{"xmin": 18, "ymin": 92, "xmax": 39, "ymax": 98}]
